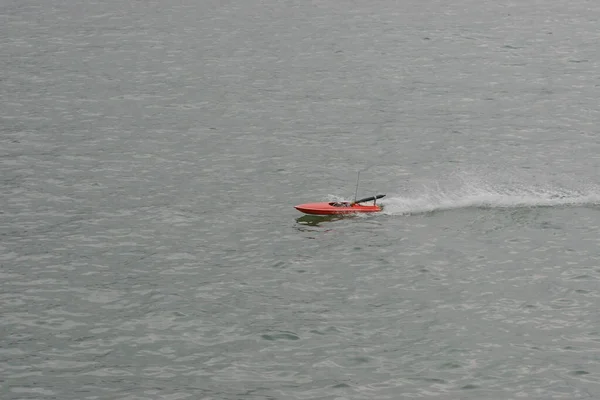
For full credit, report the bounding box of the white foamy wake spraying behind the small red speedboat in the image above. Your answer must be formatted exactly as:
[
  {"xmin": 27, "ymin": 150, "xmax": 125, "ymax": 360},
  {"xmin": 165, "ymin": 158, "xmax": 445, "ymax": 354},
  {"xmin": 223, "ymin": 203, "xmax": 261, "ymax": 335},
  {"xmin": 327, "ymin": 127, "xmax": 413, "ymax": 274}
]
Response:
[{"xmin": 382, "ymin": 184, "xmax": 600, "ymax": 215}]
